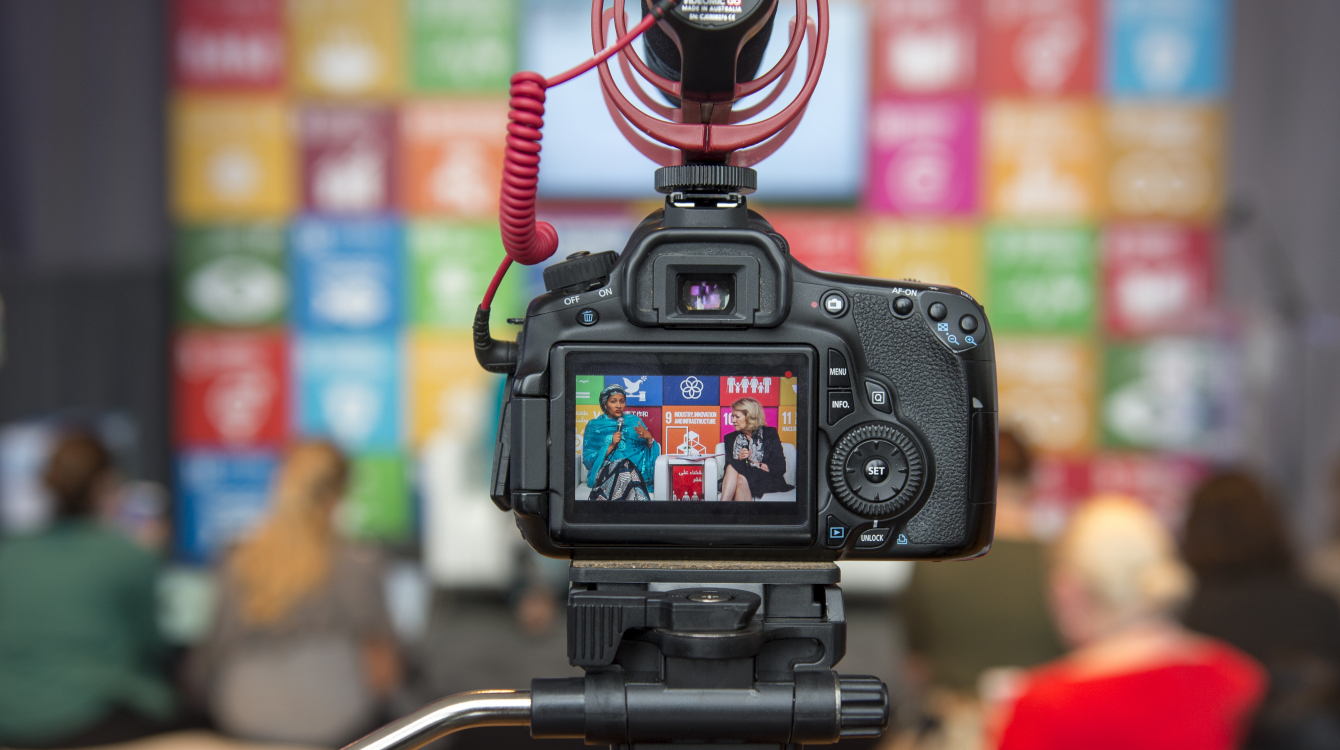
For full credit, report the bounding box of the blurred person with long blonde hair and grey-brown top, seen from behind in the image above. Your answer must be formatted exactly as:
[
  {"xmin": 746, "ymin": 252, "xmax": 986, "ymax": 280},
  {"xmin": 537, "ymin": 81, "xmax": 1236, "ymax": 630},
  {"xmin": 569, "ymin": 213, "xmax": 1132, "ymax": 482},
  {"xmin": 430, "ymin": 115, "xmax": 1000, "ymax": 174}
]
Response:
[{"xmin": 192, "ymin": 441, "xmax": 401, "ymax": 746}]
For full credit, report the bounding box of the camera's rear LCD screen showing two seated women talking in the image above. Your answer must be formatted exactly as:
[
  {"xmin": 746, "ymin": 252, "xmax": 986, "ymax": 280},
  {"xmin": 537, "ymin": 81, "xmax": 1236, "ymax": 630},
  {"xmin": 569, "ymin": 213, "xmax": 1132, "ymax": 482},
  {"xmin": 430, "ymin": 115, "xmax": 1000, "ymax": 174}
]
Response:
[{"xmin": 567, "ymin": 348, "xmax": 812, "ymax": 524}]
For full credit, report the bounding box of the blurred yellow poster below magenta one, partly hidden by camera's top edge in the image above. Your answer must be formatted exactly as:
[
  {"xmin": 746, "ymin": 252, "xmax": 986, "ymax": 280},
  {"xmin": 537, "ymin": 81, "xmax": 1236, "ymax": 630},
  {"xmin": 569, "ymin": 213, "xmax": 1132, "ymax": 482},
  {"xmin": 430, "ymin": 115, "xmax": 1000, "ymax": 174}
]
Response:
[{"xmin": 862, "ymin": 221, "xmax": 985, "ymax": 300}]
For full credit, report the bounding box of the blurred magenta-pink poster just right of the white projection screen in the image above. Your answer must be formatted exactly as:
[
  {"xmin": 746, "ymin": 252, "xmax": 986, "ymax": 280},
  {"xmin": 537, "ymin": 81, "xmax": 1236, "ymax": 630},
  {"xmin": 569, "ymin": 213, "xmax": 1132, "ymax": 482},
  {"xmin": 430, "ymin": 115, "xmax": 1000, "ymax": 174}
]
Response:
[{"xmin": 867, "ymin": 96, "xmax": 977, "ymax": 216}]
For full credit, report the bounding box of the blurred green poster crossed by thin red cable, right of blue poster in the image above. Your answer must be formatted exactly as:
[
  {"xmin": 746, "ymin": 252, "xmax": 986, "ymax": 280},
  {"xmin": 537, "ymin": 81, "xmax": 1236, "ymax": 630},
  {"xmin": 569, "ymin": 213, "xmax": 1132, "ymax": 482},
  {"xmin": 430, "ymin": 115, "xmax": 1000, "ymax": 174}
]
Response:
[{"xmin": 406, "ymin": 221, "xmax": 529, "ymax": 330}]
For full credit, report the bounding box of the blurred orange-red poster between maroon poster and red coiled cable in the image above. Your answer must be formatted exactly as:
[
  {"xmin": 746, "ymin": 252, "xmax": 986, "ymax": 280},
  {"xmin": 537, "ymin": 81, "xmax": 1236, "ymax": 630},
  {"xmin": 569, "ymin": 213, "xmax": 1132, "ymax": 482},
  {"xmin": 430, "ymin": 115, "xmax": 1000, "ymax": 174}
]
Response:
[{"xmin": 401, "ymin": 99, "xmax": 508, "ymax": 218}]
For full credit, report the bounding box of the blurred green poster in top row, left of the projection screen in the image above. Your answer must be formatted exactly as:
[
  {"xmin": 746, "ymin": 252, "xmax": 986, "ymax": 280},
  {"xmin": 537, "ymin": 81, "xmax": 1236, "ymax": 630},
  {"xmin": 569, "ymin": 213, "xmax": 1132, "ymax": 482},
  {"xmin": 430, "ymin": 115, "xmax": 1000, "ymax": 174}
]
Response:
[{"xmin": 407, "ymin": 0, "xmax": 517, "ymax": 91}]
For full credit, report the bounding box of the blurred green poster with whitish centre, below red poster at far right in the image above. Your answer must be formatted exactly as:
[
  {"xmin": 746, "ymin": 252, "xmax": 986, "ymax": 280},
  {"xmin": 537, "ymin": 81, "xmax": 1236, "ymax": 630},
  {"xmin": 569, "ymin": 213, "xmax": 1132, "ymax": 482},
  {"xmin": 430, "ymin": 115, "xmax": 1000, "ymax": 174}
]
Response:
[{"xmin": 1103, "ymin": 338, "xmax": 1234, "ymax": 451}]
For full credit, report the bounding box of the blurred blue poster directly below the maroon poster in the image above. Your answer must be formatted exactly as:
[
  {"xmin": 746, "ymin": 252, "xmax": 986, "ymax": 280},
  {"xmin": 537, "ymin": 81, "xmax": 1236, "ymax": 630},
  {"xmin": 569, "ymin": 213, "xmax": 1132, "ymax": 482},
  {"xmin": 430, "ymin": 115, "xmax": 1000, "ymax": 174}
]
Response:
[{"xmin": 291, "ymin": 218, "xmax": 405, "ymax": 333}]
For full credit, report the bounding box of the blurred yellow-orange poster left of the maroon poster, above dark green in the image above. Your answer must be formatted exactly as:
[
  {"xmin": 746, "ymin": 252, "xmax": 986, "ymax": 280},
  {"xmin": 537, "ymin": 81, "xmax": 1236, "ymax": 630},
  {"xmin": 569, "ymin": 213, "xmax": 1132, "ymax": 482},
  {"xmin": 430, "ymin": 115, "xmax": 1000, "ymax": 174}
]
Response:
[{"xmin": 170, "ymin": 95, "xmax": 296, "ymax": 222}]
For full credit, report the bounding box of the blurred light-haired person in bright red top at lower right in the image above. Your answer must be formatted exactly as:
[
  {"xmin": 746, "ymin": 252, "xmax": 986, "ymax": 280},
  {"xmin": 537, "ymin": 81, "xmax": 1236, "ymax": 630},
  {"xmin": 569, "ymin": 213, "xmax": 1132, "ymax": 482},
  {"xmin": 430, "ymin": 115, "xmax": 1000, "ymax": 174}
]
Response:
[{"xmin": 997, "ymin": 496, "xmax": 1265, "ymax": 750}]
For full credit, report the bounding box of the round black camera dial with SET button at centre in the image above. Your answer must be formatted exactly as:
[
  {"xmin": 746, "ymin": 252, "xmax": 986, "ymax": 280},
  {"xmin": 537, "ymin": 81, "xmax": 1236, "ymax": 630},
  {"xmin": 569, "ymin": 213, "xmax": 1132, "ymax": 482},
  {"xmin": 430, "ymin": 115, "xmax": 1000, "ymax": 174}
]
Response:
[{"xmin": 828, "ymin": 422, "xmax": 926, "ymax": 518}]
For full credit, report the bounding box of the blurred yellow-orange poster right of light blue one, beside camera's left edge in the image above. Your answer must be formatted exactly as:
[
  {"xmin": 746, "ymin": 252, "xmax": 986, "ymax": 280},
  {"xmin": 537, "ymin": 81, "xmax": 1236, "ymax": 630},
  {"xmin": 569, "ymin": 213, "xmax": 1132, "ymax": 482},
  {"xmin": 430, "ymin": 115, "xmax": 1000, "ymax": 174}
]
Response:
[{"xmin": 406, "ymin": 331, "xmax": 498, "ymax": 446}]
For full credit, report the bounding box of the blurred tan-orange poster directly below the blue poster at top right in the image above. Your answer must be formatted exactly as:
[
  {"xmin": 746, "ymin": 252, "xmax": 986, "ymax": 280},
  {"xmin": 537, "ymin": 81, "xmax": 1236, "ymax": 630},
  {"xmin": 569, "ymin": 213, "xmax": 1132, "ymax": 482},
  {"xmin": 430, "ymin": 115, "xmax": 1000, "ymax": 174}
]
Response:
[{"xmin": 1104, "ymin": 104, "xmax": 1225, "ymax": 221}]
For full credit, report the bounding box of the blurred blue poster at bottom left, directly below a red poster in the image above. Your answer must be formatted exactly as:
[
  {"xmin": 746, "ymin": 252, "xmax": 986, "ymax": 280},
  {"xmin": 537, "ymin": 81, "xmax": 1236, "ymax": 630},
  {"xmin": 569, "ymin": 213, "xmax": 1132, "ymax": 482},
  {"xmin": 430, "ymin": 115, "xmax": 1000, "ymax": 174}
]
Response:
[{"xmin": 176, "ymin": 451, "xmax": 279, "ymax": 563}]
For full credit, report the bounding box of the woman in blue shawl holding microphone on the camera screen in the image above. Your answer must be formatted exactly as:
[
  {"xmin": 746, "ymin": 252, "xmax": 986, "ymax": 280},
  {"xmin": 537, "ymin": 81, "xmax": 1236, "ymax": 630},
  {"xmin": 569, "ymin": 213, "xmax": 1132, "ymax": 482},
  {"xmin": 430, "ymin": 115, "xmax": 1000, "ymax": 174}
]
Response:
[{"xmin": 582, "ymin": 386, "xmax": 661, "ymax": 501}]
